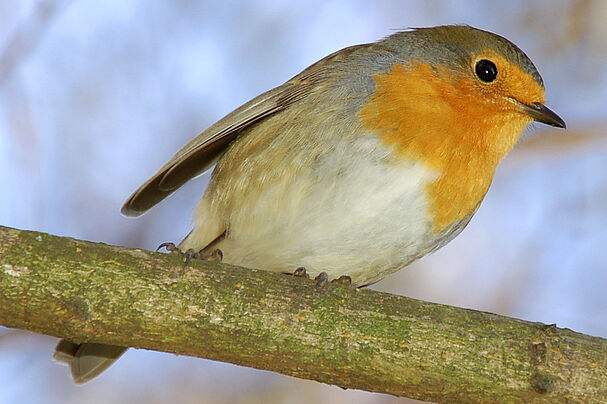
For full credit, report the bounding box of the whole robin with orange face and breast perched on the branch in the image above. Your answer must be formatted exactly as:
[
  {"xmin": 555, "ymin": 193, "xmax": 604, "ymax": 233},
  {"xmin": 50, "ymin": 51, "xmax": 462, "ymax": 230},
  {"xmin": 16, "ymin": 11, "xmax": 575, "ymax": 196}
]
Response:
[{"xmin": 58, "ymin": 26, "xmax": 565, "ymax": 382}]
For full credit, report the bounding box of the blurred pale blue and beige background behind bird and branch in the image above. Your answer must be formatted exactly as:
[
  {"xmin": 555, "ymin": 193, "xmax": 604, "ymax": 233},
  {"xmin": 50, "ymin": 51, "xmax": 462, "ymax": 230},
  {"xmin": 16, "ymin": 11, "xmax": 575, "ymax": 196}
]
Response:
[{"xmin": 0, "ymin": 0, "xmax": 607, "ymax": 403}]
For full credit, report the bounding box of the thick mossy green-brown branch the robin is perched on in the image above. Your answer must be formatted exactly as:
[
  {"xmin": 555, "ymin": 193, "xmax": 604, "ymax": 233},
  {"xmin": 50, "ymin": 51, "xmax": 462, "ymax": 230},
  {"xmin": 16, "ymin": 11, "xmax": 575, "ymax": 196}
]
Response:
[{"xmin": 0, "ymin": 226, "xmax": 607, "ymax": 403}]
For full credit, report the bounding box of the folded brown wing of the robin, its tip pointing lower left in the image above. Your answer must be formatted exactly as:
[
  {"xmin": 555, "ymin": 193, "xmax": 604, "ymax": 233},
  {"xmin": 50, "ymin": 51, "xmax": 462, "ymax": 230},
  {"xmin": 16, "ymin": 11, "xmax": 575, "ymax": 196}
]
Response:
[{"xmin": 122, "ymin": 45, "xmax": 364, "ymax": 216}]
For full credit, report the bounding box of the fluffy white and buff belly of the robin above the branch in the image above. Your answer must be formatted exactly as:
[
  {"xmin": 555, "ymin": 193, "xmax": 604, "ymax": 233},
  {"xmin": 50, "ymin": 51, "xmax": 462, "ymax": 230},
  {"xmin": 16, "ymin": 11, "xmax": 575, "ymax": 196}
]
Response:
[{"xmin": 182, "ymin": 136, "xmax": 436, "ymax": 285}]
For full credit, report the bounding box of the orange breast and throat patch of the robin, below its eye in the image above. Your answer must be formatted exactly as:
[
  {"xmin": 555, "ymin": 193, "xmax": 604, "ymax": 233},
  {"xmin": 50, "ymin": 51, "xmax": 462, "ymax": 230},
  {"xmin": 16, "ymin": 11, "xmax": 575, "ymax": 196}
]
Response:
[{"xmin": 359, "ymin": 62, "xmax": 531, "ymax": 232}]
